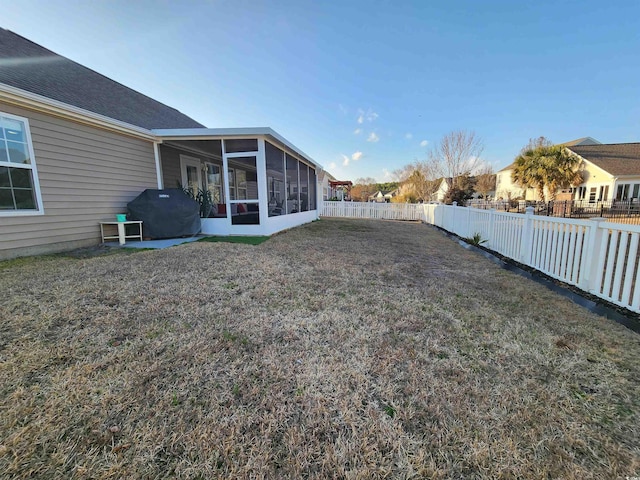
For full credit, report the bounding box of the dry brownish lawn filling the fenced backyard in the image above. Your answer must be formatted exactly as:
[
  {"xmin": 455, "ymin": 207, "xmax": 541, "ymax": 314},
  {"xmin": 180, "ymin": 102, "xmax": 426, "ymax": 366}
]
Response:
[{"xmin": 0, "ymin": 220, "xmax": 640, "ymax": 479}]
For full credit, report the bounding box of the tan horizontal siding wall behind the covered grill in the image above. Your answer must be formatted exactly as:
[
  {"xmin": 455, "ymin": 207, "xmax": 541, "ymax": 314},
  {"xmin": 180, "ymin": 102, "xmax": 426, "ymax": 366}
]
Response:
[{"xmin": 0, "ymin": 102, "xmax": 157, "ymax": 258}]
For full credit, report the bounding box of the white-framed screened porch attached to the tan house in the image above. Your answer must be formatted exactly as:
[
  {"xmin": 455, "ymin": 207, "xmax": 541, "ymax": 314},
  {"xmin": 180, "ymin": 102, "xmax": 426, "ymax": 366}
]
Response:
[{"xmin": 154, "ymin": 128, "xmax": 321, "ymax": 235}]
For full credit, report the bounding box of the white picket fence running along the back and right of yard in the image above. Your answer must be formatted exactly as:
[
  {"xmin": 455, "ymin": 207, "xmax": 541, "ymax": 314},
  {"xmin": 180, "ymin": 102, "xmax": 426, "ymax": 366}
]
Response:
[{"xmin": 320, "ymin": 202, "xmax": 640, "ymax": 313}]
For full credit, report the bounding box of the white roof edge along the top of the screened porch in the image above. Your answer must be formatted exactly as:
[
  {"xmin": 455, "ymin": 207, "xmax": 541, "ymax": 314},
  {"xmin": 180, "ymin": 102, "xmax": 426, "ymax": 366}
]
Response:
[{"xmin": 151, "ymin": 127, "xmax": 322, "ymax": 169}]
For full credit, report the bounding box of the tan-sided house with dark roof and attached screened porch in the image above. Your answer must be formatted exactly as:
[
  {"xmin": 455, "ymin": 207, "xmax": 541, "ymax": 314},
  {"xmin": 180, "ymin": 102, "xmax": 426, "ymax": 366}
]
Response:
[{"xmin": 0, "ymin": 28, "xmax": 322, "ymax": 258}]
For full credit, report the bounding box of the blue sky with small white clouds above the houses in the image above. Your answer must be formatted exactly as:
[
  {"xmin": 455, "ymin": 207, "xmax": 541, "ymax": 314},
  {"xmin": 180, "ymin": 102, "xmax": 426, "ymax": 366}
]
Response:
[{"xmin": 0, "ymin": 0, "xmax": 640, "ymax": 181}]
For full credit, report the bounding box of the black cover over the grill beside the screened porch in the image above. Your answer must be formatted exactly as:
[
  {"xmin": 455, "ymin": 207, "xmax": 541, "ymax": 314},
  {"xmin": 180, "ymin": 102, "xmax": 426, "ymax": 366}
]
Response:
[{"xmin": 127, "ymin": 188, "xmax": 201, "ymax": 238}]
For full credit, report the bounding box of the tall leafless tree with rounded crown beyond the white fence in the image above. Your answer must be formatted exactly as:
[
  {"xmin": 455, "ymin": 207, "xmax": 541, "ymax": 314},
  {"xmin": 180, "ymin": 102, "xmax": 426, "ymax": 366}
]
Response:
[{"xmin": 429, "ymin": 130, "xmax": 484, "ymax": 187}]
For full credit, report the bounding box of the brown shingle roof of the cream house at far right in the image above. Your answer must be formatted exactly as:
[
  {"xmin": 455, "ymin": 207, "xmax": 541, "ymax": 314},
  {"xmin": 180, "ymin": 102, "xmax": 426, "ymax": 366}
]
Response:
[{"xmin": 569, "ymin": 143, "xmax": 640, "ymax": 175}]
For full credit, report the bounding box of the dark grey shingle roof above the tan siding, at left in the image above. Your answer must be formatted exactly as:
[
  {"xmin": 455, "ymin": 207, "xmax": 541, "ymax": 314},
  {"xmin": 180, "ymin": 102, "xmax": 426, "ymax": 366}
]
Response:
[{"xmin": 0, "ymin": 28, "xmax": 204, "ymax": 129}]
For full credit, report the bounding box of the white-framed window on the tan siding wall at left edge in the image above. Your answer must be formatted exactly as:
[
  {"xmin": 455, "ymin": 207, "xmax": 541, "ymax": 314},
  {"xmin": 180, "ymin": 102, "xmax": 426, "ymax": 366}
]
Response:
[{"xmin": 0, "ymin": 113, "xmax": 44, "ymax": 216}]
